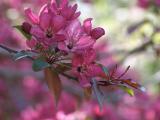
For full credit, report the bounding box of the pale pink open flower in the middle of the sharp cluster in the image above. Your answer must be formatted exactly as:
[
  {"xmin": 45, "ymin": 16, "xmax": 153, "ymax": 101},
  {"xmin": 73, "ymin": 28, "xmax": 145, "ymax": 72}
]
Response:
[{"xmin": 59, "ymin": 19, "xmax": 95, "ymax": 52}]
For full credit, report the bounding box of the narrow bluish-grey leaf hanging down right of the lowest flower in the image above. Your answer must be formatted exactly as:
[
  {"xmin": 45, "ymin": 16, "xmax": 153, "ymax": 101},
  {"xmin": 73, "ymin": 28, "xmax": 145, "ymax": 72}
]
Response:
[{"xmin": 92, "ymin": 79, "xmax": 104, "ymax": 110}]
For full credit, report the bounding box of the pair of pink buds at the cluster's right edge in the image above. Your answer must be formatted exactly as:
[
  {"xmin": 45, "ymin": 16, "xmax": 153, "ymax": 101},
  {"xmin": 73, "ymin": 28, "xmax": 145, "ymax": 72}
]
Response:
[{"xmin": 83, "ymin": 18, "xmax": 105, "ymax": 40}]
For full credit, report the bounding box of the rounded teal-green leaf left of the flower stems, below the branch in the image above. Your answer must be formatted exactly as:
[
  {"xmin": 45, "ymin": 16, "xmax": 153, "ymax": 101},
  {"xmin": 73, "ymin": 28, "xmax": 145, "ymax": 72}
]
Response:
[{"xmin": 32, "ymin": 59, "xmax": 51, "ymax": 72}]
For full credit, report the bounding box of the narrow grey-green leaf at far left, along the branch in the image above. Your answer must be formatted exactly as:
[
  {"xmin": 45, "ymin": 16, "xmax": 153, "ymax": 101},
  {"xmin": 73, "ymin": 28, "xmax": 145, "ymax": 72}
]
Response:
[{"xmin": 13, "ymin": 51, "xmax": 36, "ymax": 61}]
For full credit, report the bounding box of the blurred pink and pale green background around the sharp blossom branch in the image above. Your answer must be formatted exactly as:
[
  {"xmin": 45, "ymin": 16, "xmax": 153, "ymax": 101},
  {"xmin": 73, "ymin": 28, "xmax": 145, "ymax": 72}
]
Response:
[{"xmin": 0, "ymin": 0, "xmax": 160, "ymax": 120}]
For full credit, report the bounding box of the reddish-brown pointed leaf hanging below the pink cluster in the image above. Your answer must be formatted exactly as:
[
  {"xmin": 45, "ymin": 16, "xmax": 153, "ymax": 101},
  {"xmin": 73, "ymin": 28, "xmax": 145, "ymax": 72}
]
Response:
[{"xmin": 44, "ymin": 68, "xmax": 62, "ymax": 105}]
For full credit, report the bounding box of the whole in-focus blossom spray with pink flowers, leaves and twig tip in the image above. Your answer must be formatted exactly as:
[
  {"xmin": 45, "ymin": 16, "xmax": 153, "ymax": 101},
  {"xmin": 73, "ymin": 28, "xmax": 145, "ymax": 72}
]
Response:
[{"xmin": 15, "ymin": 0, "xmax": 144, "ymax": 107}]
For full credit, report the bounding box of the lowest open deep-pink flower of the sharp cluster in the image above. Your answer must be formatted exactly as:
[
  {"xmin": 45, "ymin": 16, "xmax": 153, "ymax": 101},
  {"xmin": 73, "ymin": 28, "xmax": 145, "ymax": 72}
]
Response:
[{"xmin": 72, "ymin": 49, "xmax": 102, "ymax": 87}]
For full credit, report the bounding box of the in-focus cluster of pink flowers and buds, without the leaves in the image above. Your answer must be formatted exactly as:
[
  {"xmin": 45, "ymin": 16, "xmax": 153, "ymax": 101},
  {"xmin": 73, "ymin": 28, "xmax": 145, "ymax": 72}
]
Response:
[{"xmin": 22, "ymin": 0, "xmax": 105, "ymax": 86}]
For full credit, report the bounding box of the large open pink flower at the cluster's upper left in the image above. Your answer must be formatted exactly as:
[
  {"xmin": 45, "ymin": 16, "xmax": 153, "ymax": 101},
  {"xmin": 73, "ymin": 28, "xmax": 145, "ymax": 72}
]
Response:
[{"xmin": 25, "ymin": 5, "xmax": 66, "ymax": 45}]
